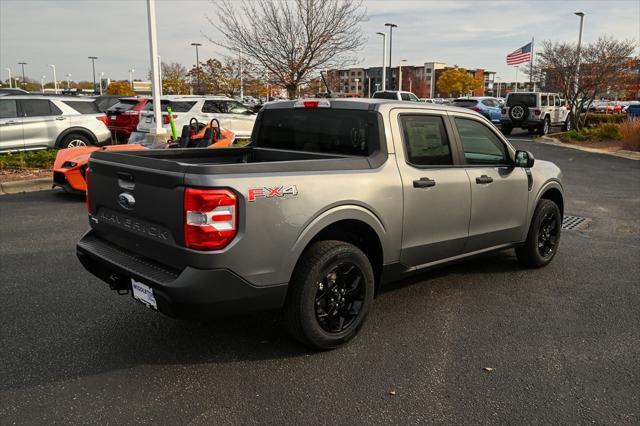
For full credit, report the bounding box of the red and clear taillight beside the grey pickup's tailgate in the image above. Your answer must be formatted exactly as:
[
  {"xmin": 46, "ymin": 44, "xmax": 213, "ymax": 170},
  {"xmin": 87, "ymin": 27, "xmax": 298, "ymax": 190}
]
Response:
[{"xmin": 184, "ymin": 188, "xmax": 238, "ymax": 250}]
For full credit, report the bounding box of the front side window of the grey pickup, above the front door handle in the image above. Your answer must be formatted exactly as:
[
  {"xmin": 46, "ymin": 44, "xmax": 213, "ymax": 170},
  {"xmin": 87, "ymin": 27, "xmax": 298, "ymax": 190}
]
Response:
[{"xmin": 455, "ymin": 118, "xmax": 509, "ymax": 164}]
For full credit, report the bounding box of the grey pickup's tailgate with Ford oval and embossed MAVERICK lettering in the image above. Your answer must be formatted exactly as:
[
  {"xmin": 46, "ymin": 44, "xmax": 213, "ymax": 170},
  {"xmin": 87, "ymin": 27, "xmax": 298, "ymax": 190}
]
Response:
[{"xmin": 88, "ymin": 151, "xmax": 187, "ymax": 268}]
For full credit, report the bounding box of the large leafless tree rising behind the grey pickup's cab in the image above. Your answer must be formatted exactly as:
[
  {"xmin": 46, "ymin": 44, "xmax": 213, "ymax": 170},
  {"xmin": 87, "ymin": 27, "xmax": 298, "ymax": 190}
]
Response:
[{"xmin": 209, "ymin": 0, "xmax": 365, "ymax": 98}]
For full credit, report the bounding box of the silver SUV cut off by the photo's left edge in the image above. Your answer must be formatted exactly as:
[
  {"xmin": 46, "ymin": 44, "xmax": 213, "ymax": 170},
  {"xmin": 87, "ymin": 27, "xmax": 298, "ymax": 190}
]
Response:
[{"xmin": 0, "ymin": 95, "xmax": 111, "ymax": 152}]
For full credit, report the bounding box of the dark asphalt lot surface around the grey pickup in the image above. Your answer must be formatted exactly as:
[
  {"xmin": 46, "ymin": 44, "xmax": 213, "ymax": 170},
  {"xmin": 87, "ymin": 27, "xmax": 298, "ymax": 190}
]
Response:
[{"xmin": 0, "ymin": 138, "xmax": 640, "ymax": 424}]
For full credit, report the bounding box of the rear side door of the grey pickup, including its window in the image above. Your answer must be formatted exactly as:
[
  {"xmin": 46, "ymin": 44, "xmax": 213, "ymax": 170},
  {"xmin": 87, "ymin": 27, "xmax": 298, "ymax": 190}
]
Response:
[{"xmin": 391, "ymin": 109, "xmax": 471, "ymax": 267}]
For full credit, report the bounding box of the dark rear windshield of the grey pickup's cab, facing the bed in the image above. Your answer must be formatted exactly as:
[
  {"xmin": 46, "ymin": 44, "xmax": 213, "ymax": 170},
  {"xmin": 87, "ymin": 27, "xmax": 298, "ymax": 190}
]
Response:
[{"xmin": 256, "ymin": 108, "xmax": 380, "ymax": 156}]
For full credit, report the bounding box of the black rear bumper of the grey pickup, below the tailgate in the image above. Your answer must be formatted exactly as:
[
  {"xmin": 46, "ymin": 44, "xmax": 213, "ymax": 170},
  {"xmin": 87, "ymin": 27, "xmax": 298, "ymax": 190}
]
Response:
[{"xmin": 76, "ymin": 231, "xmax": 287, "ymax": 318}]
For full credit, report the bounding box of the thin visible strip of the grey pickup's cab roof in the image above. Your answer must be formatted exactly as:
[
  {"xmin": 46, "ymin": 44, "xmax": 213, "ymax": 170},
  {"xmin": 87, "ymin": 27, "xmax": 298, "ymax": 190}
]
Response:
[{"xmin": 263, "ymin": 98, "xmax": 476, "ymax": 113}]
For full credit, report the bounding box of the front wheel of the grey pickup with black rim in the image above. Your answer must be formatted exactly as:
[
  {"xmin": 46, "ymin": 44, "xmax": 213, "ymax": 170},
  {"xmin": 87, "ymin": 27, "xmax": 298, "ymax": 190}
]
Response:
[{"xmin": 516, "ymin": 199, "xmax": 562, "ymax": 268}]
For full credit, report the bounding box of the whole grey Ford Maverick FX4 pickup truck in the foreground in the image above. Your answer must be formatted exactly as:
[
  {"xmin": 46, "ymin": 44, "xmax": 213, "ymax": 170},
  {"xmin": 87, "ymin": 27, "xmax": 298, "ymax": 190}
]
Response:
[{"xmin": 77, "ymin": 99, "xmax": 564, "ymax": 349}]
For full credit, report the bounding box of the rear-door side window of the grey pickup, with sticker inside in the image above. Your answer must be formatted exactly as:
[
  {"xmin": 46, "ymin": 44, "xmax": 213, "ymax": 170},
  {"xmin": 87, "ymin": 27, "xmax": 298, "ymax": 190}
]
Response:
[{"xmin": 400, "ymin": 115, "xmax": 453, "ymax": 166}]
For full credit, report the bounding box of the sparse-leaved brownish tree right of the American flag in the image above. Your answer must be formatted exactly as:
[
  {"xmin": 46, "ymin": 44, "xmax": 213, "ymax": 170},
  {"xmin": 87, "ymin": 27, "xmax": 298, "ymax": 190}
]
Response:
[{"xmin": 528, "ymin": 36, "xmax": 637, "ymax": 128}]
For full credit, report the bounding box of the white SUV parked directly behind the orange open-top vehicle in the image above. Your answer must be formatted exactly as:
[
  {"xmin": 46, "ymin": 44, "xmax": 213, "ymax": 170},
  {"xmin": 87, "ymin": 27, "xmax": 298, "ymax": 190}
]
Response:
[{"xmin": 137, "ymin": 96, "xmax": 256, "ymax": 140}]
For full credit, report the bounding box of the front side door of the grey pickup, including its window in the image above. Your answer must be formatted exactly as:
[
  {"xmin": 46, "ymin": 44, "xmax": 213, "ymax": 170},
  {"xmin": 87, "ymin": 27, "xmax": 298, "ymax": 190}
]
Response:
[{"xmin": 452, "ymin": 114, "xmax": 529, "ymax": 252}]
